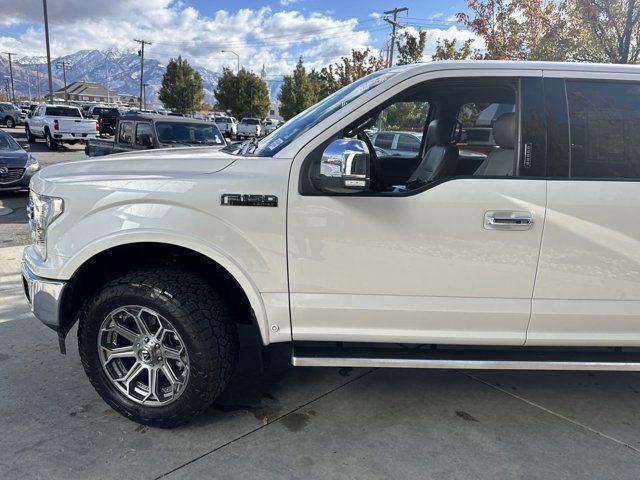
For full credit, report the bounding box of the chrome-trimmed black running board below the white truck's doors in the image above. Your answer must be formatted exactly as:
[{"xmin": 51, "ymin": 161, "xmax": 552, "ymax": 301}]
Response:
[{"xmin": 292, "ymin": 347, "xmax": 640, "ymax": 371}]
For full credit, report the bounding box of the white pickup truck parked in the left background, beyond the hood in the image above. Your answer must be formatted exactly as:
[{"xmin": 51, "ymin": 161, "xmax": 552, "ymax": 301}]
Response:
[{"xmin": 24, "ymin": 103, "xmax": 100, "ymax": 150}]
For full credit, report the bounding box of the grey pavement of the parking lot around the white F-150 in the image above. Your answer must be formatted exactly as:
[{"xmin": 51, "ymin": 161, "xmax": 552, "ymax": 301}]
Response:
[{"xmin": 0, "ymin": 129, "xmax": 640, "ymax": 480}]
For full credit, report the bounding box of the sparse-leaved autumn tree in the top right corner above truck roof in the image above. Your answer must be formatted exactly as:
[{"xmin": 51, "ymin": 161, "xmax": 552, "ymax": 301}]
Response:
[{"xmin": 567, "ymin": 0, "xmax": 640, "ymax": 63}]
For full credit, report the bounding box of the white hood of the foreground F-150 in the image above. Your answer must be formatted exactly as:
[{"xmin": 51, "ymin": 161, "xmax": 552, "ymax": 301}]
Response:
[{"xmin": 31, "ymin": 147, "xmax": 238, "ymax": 193}]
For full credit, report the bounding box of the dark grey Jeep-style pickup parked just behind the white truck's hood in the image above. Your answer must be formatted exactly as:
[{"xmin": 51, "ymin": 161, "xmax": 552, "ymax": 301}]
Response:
[{"xmin": 85, "ymin": 114, "xmax": 227, "ymax": 157}]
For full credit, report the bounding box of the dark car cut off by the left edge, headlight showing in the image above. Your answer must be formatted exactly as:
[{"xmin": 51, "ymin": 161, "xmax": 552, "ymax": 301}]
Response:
[{"xmin": 0, "ymin": 131, "xmax": 40, "ymax": 190}]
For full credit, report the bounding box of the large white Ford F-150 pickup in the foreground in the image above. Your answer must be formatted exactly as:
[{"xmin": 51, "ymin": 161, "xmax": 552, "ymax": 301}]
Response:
[{"xmin": 22, "ymin": 61, "xmax": 640, "ymax": 427}]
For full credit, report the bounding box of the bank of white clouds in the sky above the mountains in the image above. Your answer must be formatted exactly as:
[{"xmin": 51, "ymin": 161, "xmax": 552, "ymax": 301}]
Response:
[{"xmin": 0, "ymin": 0, "xmax": 378, "ymax": 74}]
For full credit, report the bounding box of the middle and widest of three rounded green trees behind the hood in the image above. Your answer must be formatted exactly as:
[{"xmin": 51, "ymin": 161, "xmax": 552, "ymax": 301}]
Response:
[{"xmin": 214, "ymin": 68, "xmax": 271, "ymax": 118}]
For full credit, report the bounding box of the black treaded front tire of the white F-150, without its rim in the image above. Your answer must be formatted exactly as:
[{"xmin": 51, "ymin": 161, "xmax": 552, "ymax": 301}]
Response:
[{"xmin": 78, "ymin": 268, "xmax": 238, "ymax": 428}]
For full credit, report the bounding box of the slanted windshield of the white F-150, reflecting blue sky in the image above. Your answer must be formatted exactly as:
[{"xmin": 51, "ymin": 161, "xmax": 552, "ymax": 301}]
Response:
[{"xmin": 252, "ymin": 67, "xmax": 403, "ymax": 157}]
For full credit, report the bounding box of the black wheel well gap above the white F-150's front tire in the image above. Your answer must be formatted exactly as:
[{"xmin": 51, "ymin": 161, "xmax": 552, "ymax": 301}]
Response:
[{"xmin": 60, "ymin": 242, "xmax": 255, "ymax": 335}]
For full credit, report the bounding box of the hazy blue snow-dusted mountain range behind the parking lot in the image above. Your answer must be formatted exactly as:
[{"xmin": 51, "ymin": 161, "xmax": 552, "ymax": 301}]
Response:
[{"xmin": 0, "ymin": 49, "xmax": 282, "ymax": 105}]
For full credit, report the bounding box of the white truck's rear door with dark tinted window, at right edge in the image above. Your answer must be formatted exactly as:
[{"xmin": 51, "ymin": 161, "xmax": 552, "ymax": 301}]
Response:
[{"xmin": 527, "ymin": 72, "xmax": 640, "ymax": 346}]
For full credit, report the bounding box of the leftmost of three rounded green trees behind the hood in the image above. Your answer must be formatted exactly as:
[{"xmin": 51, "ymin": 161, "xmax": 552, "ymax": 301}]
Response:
[{"xmin": 158, "ymin": 56, "xmax": 204, "ymax": 113}]
